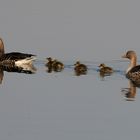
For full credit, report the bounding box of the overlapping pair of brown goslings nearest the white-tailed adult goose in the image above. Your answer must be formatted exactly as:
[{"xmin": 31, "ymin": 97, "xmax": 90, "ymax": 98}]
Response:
[{"xmin": 46, "ymin": 57, "xmax": 64, "ymax": 73}]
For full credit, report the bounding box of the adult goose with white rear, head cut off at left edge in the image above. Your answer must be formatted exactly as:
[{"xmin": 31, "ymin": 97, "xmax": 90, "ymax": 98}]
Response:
[{"xmin": 0, "ymin": 38, "xmax": 36, "ymax": 67}]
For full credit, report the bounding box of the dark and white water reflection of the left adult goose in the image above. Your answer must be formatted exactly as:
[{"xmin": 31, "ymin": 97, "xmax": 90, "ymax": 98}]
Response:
[{"xmin": 0, "ymin": 65, "xmax": 36, "ymax": 84}]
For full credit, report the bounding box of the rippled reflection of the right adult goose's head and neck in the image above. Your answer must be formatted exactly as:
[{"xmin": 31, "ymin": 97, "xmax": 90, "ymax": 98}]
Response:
[{"xmin": 122, "ymin": 81, "xmax": 137, "ymax": 101}]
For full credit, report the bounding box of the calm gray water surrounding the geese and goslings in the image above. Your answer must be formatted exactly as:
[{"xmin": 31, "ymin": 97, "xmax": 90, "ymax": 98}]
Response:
[{"xmin": 0, "ymin": 0, "xmax": 140, "ymax": 140}]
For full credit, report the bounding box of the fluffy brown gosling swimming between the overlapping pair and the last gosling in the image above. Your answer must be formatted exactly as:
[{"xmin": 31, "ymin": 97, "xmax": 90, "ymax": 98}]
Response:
[{"xmin": 74, "ymin": 61, "xmax": 87, "ymax": 76}]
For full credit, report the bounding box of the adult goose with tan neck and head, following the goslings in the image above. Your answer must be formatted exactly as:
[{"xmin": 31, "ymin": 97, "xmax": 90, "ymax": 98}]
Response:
[{"xmin": 122, "ymin": 50, "xmax": 140, "ymax": 84}]
